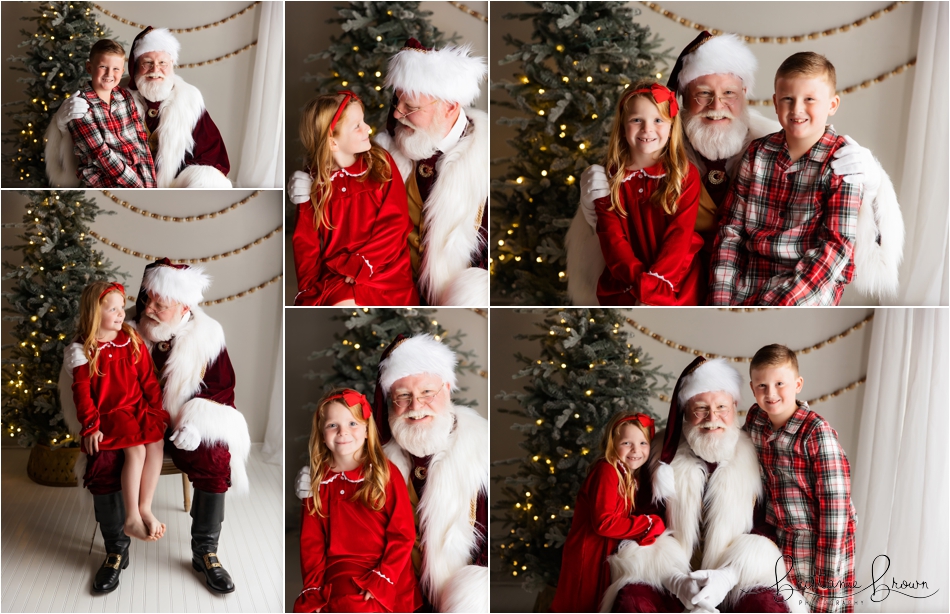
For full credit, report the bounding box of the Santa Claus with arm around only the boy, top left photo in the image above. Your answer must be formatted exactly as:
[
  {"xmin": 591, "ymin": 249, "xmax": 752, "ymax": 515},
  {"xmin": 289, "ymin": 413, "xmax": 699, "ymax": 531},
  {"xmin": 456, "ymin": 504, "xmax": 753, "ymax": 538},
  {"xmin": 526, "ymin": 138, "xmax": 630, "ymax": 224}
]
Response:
[{"xmin": 46, "ymin": 26, "xmax": 231, "ymax": 189}]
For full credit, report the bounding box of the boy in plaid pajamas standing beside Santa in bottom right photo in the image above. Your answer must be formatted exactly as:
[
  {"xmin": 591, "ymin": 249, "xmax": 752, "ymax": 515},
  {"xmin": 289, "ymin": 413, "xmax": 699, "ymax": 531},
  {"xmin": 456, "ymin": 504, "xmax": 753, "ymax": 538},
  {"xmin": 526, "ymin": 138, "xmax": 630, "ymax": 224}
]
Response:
[{"xmin": 743, "ymin": 344, "xmax": 857, "ymax": 612}]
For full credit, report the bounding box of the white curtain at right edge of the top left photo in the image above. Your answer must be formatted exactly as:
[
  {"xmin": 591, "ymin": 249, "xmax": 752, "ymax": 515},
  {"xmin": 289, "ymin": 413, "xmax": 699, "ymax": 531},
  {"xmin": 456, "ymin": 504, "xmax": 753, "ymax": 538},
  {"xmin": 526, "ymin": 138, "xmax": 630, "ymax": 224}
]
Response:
[{"xmin": 236, "ymin": 2, "xmax": 284, "ymax": 188}]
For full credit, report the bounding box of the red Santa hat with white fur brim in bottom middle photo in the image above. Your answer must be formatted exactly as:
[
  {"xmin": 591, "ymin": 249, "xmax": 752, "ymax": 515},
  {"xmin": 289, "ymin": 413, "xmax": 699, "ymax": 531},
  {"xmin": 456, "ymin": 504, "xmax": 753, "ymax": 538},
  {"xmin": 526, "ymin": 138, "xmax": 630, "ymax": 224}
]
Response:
[{"xmin": 373, "ymin": 333, "xmax": 458, "ymax": 443}]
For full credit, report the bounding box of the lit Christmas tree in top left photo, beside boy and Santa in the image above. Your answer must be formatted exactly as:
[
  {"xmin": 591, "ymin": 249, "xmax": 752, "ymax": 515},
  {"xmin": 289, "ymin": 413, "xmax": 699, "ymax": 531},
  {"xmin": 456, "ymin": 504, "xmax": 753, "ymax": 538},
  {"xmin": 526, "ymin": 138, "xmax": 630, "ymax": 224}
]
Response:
[{"xmin": 3, "ymin": 2, "xmax": 118, "ymax": 188}]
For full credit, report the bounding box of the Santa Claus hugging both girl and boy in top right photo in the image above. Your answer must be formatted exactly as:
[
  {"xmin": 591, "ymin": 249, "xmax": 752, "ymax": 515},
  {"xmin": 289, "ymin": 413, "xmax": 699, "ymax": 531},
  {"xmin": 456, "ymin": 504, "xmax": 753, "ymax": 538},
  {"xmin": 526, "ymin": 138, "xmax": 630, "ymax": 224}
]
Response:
[{"xmin": 565, "ymin": 32, "xmax": 904, "ymax": 305}]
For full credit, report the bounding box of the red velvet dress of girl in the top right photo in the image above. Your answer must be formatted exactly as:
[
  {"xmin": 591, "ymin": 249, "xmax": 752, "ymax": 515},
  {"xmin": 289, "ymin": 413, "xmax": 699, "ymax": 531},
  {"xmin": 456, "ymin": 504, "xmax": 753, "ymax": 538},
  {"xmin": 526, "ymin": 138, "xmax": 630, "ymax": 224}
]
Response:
[{"xmin": 594, "ymin": 163, "xmax": 707, "ymax": 306}]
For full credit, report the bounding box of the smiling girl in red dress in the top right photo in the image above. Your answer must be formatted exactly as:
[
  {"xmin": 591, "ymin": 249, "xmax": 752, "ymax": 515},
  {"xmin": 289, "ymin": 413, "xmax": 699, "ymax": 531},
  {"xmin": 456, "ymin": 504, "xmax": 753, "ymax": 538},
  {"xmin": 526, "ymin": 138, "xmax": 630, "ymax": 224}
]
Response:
[{"xmin": 594, "ymin": 83, "xmax": 706, "ymax": 305}]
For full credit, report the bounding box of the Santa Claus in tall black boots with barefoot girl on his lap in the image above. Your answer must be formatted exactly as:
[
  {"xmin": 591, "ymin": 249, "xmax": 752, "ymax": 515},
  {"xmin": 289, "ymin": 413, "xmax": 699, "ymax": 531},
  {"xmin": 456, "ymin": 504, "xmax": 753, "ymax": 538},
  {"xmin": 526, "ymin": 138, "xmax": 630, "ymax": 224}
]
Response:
[{"xmin": 60, "ymin": 258, "xmax": 251, "ymax": 593}]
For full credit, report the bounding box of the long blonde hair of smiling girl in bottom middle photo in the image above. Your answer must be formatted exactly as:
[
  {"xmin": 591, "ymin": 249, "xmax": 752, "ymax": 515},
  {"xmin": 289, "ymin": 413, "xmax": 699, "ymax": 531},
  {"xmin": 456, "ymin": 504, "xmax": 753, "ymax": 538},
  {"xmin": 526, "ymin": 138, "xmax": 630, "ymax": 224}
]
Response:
[{"xmin": 310, "ymin": 388, "xmax": 389, "ymax": 518}]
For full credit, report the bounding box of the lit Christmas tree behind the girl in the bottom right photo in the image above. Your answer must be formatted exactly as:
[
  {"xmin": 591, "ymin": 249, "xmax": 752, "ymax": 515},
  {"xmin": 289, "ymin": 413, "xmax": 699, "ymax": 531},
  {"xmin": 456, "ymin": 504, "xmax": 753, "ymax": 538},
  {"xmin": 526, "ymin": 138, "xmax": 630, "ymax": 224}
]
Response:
[{"xmin": 492, "ymin": 309, "xmax": 673, "ymax": 596}]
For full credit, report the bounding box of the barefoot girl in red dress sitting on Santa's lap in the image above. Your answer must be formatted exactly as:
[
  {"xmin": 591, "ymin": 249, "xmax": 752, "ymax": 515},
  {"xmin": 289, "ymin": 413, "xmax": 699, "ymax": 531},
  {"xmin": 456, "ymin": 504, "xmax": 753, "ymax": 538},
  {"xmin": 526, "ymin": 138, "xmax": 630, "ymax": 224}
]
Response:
[{"xmin": 71, "ymin": 281, "xmax": 171, "ymax": 541}]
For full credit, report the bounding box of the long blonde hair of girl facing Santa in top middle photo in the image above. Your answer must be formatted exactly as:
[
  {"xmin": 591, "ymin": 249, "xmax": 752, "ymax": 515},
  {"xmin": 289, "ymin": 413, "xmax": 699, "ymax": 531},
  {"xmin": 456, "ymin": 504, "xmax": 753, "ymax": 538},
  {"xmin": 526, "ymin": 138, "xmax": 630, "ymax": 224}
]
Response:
[{"xmin": 300, "ymin": 94, "xmax": 392, "ymax": 230}]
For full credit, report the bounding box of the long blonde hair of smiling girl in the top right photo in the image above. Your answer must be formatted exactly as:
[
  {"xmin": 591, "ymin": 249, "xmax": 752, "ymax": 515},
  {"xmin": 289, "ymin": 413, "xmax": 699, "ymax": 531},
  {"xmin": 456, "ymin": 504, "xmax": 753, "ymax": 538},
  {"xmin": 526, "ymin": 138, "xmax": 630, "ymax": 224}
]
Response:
[{"xmin": 604, "ymin": 81, "xmax": 689, "ymax": 217}]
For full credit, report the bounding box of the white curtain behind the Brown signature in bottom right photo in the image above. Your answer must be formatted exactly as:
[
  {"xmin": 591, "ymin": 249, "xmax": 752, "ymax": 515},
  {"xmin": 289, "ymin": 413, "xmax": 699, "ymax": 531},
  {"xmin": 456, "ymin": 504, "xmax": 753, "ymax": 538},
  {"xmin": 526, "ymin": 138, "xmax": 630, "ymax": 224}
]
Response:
[{"xmin": 851, "ymin": 310, "xmax": 950, "ymax": 612}]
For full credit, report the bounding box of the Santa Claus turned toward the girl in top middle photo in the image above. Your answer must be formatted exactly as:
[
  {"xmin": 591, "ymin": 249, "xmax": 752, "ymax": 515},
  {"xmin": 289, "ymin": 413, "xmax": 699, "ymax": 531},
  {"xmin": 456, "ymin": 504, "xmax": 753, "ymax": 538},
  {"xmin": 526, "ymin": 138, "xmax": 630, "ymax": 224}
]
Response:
[{"xmin": 288, "ymin": 39, "xmax": 489, "ymax": 307}]
